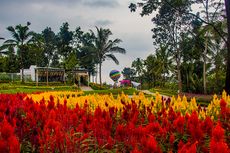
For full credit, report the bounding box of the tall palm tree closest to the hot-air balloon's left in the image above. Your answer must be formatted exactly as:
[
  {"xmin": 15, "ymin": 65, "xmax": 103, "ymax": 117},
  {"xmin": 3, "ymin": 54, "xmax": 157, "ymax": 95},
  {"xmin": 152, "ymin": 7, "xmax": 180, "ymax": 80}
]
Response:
[{"xmin": 94, "ymin": 27, "xmax": 126, "ymax": 86}]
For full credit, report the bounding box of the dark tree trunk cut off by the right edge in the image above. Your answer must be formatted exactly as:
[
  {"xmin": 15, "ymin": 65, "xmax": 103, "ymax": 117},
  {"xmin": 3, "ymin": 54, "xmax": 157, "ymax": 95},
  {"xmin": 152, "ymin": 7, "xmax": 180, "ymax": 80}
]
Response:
[{"xmin": 225, "ymin": 0, "xmax": 230, "ymax": 94}]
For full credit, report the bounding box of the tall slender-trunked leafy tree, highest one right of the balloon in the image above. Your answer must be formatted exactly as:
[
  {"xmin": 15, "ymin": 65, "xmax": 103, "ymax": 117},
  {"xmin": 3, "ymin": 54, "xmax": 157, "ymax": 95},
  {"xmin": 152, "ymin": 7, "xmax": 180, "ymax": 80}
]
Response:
[{"xmin": 139, "ymin": 0, "xmax": 191, "ymax": 92}]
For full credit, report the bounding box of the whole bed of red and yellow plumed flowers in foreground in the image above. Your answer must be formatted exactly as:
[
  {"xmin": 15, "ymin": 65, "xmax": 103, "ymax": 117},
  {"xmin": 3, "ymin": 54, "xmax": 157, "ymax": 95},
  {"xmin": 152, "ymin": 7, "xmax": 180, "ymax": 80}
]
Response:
[{"xmin": 0, "ymin": 92, "xmax": 230, "ymax": 153}]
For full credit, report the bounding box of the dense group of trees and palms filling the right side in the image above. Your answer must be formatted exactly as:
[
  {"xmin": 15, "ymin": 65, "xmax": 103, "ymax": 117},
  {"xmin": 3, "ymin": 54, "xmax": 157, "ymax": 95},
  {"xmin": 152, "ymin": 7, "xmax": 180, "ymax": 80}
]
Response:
[{"xmin": 129, "ymin": 0, "xmax": 230, "ymax": 93}]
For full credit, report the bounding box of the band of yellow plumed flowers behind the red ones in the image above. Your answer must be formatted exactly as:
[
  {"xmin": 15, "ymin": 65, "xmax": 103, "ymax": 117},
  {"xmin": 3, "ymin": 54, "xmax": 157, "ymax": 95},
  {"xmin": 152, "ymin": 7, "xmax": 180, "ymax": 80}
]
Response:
[{"xmin": 27, "ymin": 91, "xmax": 230, "ymax": 119}]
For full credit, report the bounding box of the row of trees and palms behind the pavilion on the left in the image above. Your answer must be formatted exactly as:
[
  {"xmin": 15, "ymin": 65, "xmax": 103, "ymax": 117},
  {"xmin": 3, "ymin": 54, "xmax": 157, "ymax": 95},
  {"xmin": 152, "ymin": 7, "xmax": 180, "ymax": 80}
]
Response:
[{"xmin": 0, "ymin": 22, "xmax": 126, "ymax": 84}]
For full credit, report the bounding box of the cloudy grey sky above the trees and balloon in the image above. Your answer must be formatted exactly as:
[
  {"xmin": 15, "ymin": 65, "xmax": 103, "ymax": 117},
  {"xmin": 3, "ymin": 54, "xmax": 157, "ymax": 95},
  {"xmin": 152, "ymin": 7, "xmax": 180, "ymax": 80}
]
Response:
[{"xmin": 0, "ymin": 0, "xmax": 154, "ymax": 83}]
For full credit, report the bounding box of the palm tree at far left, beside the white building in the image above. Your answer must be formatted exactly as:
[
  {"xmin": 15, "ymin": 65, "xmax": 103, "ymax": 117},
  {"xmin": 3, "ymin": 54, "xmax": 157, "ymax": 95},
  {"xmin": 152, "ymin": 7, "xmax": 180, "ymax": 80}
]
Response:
[{"xmin": 3, "ymin": 22, "xmax": 33, "ymax": 83}]
